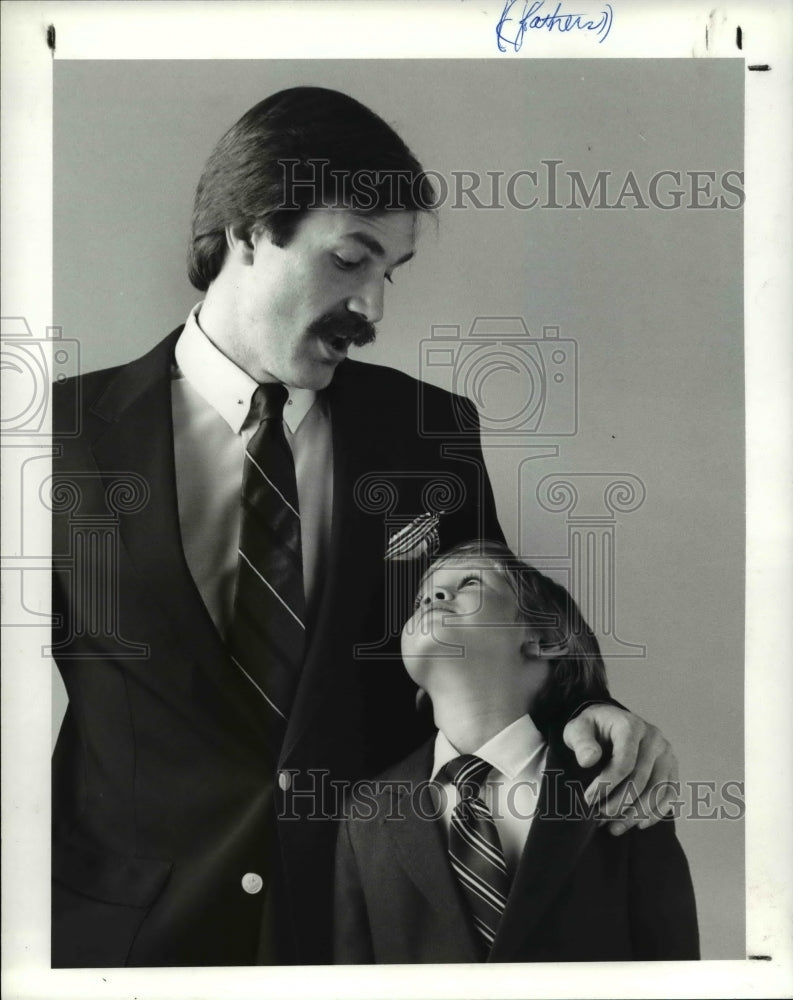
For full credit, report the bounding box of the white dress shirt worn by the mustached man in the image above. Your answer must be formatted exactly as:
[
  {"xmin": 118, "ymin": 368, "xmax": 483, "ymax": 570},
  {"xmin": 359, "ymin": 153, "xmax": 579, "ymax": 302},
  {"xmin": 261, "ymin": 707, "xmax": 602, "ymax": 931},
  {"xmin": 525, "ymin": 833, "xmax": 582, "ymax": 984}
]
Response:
[{"xmin": 171, "ymin": 303, "xmax": 333, "ymax": 637}]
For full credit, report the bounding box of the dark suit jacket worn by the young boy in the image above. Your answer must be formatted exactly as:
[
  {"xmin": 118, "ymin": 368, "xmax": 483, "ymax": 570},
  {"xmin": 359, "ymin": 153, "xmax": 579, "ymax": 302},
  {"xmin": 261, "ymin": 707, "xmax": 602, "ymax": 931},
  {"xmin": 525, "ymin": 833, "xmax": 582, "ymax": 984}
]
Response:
[{"xmin": 335, "ymin": 740, "xmax": 699, "ymax": 964}]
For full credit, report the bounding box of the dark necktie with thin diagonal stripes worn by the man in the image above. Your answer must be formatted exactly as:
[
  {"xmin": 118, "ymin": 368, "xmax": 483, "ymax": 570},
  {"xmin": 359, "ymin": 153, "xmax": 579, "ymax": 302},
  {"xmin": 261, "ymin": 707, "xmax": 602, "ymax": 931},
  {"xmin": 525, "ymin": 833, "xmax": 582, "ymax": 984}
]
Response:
[{"xmin": 228, "ymin": 383, "xmax": 306, "ymax": 748}]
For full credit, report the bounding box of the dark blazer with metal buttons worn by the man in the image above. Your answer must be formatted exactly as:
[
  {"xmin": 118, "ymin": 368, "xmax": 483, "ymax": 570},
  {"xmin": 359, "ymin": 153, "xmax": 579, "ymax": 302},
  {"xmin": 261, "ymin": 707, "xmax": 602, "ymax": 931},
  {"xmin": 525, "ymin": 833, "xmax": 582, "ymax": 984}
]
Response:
[{"xmin": 52, "ymin": 330, "xmax": 501, "ymax": 966}]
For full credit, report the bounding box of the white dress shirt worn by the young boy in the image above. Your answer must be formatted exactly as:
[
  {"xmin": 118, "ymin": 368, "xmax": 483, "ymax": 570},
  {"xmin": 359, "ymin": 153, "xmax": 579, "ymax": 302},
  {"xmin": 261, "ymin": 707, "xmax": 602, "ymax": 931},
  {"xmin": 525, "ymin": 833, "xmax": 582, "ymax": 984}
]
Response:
[{"xmin": 432, "ymin": 715, "xmax": 548, "ymax": 878}]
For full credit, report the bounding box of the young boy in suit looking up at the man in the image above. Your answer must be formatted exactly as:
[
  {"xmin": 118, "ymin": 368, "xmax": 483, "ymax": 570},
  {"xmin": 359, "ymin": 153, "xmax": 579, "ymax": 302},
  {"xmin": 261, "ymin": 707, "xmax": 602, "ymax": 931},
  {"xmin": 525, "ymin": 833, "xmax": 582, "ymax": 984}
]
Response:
[{"xmin": 335, "ymin": 542, "xmax": 699, "ymax": 963}]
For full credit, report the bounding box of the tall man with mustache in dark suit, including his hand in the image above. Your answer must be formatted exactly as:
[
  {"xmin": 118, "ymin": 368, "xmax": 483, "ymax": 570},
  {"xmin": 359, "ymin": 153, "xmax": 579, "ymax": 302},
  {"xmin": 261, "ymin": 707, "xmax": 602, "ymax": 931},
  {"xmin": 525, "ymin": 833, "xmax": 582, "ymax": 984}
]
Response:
[{"xmin": 52, "ymin": 88, "xmax": 674, "ymax": 966}]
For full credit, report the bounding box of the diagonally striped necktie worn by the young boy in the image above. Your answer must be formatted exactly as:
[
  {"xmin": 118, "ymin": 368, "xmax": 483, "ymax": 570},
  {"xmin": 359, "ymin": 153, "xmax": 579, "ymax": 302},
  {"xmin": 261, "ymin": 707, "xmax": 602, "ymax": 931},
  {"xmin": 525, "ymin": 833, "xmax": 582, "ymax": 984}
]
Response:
[{"xmin": 443, "ymin": 754, "xmax": 509, "ymax": 951}]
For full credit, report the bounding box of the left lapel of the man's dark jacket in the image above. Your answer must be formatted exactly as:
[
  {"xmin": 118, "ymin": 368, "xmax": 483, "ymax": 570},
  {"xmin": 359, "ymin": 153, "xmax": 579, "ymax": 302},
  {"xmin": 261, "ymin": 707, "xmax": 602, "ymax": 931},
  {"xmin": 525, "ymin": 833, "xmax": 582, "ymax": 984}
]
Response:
[{"xmin": 92, "ymin": 329, "xmax": 266, "ymax": 738}]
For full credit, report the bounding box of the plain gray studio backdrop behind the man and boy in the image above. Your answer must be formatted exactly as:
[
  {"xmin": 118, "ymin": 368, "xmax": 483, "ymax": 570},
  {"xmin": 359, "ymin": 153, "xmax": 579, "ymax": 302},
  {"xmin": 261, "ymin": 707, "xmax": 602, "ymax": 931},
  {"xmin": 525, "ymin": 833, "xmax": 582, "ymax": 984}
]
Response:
[{"xmin": 53, "ymin": 58, "xmax": 744, "ymax": 958}]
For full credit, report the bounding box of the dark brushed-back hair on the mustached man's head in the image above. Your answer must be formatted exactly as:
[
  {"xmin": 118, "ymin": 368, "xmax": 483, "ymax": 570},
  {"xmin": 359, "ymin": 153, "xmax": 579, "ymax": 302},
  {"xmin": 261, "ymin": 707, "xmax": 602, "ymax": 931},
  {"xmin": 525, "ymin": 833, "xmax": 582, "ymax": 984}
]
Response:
[{"xmin": 188, "ymin": 87, "xmax": 436, "ymax": 291}]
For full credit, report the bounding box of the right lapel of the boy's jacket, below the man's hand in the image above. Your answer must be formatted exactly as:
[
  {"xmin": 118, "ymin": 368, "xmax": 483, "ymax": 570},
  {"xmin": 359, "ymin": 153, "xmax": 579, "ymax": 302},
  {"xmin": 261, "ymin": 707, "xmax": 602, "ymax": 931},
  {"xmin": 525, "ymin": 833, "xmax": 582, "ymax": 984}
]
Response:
[{"xmin": 488, "ymin": 742, "xmax": 597, "ymax": 962}]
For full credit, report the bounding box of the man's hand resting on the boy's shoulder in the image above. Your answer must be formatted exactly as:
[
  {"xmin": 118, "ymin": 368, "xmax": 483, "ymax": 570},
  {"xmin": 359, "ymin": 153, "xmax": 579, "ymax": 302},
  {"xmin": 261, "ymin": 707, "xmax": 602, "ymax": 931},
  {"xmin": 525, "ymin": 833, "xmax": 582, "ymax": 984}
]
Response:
[{"xmin": 562, "ymin": 702, "xmax": 680, "ymax": 836}]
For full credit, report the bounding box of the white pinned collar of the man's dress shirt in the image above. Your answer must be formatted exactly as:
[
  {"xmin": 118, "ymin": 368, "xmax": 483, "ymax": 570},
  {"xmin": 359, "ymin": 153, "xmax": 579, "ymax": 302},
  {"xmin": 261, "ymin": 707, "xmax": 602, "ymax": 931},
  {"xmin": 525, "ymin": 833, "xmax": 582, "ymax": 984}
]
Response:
[{"xmin": 175, "ymin": 302, "xmax": 317, "ymax": 434}]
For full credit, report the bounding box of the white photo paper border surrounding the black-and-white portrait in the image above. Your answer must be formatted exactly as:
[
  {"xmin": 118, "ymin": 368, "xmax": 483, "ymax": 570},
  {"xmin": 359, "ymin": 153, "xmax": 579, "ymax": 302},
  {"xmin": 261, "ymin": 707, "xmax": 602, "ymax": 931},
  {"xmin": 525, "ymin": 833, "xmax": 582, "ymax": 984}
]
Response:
[{"xmin": 2, "ymin": 0, "xmax": 793, "ymax": 1000}]
